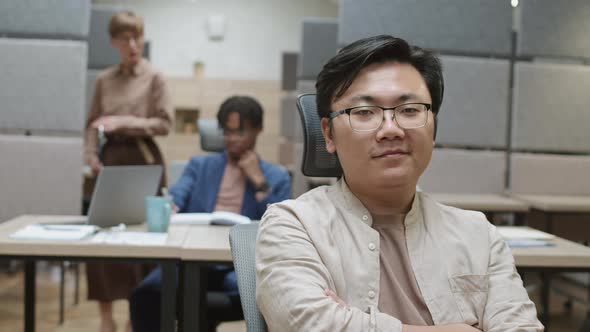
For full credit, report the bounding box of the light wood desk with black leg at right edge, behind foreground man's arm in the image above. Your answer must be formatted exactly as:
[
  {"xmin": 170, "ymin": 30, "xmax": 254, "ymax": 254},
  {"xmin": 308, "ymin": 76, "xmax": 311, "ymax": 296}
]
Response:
[{"xmin": 512, "ymin": 226, "xmax": 590, "ymax": 325}]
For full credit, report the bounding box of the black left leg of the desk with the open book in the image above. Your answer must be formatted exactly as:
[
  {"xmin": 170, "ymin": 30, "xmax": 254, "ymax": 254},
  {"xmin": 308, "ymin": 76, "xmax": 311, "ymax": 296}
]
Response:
[{"xmin": 182, "ymin": 262, "xmax": 207, "ymax": 332}]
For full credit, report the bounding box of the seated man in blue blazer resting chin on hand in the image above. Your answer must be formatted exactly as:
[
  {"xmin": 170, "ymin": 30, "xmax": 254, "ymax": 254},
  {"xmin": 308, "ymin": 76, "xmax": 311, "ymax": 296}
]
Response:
[{"xmin": 130, "ymin": 97, "xmax": 291, "ymax": 332}]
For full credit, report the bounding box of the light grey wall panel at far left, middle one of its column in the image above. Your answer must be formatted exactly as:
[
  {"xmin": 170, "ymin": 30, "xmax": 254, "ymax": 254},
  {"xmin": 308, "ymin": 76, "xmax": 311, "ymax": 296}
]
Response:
[{"xmin": 0, "ymin": 38, "xmax": 86, "ymax": 133}]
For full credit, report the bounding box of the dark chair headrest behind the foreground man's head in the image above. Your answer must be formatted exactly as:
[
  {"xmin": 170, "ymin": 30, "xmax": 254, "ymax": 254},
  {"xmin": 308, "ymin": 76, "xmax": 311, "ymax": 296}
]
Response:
[{"xmin": 297, "ymin": 94, "xmax": 342, "ymax": 177}]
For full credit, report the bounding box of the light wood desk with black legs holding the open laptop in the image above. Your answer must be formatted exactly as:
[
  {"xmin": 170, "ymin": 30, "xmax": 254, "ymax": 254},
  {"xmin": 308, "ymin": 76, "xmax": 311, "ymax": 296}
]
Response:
[{"xmin": 0, "ymin": 215, "xmax": 188, "ymax": 332}]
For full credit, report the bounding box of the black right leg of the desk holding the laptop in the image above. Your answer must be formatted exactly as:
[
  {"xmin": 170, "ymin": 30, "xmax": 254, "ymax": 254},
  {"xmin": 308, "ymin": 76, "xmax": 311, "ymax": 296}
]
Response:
[{"xmin": 160, "ymin": 262, "xmax": 176, "ymax": 332}]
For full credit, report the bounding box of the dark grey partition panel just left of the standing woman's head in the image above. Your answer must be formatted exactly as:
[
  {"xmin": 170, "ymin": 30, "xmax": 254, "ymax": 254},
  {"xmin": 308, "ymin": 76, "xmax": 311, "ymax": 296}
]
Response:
[{"xmin": 88, "ymin": 5, "xmax": 122, "ymax": 69}]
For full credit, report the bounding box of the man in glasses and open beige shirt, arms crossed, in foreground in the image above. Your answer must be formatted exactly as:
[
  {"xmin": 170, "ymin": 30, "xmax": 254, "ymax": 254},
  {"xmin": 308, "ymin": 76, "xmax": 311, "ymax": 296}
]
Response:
[{"xmin": 256, "ymin": 35, "xmax": 543, "ymax": 332}]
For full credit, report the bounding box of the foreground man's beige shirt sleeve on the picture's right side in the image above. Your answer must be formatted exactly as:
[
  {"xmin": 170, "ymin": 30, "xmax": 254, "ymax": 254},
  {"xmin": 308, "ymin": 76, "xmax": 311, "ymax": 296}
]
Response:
[{"xmin": 483, "ymin": 225, "xmax": 544, "ymax": 332}]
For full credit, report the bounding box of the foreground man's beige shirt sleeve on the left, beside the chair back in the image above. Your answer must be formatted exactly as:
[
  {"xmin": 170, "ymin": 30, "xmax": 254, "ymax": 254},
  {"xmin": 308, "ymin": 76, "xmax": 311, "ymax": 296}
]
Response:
[{"xmin": 256, "ymin": 205, "xmax": 402, "ymax": 332}]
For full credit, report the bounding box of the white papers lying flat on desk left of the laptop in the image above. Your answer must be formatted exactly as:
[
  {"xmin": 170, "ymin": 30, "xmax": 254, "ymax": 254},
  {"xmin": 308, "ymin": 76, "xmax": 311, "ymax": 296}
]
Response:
[{"xmin": 10, "ymin": 224, "xmax": 98, "ymax": 241}]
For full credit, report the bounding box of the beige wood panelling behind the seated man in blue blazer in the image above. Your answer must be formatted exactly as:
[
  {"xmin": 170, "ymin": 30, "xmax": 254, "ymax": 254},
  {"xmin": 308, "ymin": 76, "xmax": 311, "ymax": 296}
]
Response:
[{"xmin": 157, "ymin": 78, "xmax": 281, "ymax": 163}]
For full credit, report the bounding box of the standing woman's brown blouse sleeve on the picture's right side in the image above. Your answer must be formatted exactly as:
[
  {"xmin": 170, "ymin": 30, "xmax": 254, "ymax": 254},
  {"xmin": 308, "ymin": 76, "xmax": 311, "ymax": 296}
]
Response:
[{"xmin": 114, "ymin": 74, "xmax": 173, "ymax": 136}]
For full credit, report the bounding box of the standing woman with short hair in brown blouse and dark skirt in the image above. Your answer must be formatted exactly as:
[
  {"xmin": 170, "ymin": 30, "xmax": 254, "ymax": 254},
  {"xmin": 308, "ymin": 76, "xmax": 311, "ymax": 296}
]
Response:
[{"xmin": 85, "ymin": 11, "xmax": 172, "ymax": 332}]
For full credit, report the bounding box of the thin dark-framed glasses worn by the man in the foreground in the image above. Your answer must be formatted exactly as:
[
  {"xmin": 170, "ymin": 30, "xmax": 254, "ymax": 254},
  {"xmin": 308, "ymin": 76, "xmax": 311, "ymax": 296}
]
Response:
[{"xmin": 329, "ymin": 103, "xmax": 432, "ymax": 131}]
